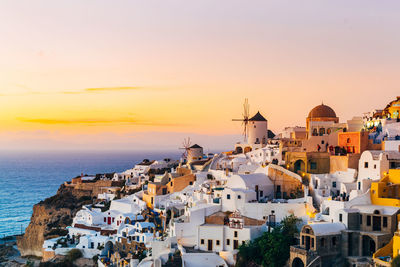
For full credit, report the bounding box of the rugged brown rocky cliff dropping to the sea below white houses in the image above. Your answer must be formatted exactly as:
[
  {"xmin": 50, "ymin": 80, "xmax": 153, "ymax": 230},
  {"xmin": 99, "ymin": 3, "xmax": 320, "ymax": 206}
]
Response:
[{"xmin": 17, "ymin": 185, "xmax": 93, "ymax": 257}]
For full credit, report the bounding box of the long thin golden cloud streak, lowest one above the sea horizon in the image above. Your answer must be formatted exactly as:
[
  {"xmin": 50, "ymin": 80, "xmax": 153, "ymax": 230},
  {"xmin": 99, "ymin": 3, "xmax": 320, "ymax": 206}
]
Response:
[{"xmin": 16, "ymin": 117, "xmax": 179, "ymax": 126}]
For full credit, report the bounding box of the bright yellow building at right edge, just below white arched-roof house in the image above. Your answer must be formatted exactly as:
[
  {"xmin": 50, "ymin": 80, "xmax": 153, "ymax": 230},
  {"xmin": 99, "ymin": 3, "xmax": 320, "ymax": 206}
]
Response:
[{"xmin": 371, "ymin": 169, "xmax": 400, "ymax": 207}]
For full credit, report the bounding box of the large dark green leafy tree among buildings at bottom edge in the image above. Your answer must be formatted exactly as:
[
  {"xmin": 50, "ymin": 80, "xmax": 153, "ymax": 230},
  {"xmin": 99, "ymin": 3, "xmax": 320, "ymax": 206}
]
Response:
[{"xmin": 236, "ymin": 215, "xmax": 300, "ymax": 267}]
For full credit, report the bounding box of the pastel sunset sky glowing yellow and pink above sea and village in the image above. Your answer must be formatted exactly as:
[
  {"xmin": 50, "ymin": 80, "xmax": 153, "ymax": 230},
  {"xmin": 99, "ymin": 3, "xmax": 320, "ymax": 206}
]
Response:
[{"xmin": 0, "ymin": 0, "xmax": 400, "ymax": 153}]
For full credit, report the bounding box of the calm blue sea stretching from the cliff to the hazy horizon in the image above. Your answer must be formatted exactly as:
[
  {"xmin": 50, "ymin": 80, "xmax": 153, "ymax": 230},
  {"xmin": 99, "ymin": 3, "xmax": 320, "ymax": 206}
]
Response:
[{"xmin": 0, "ymin": 151, "xmax": 180, "ymax": 237}]
